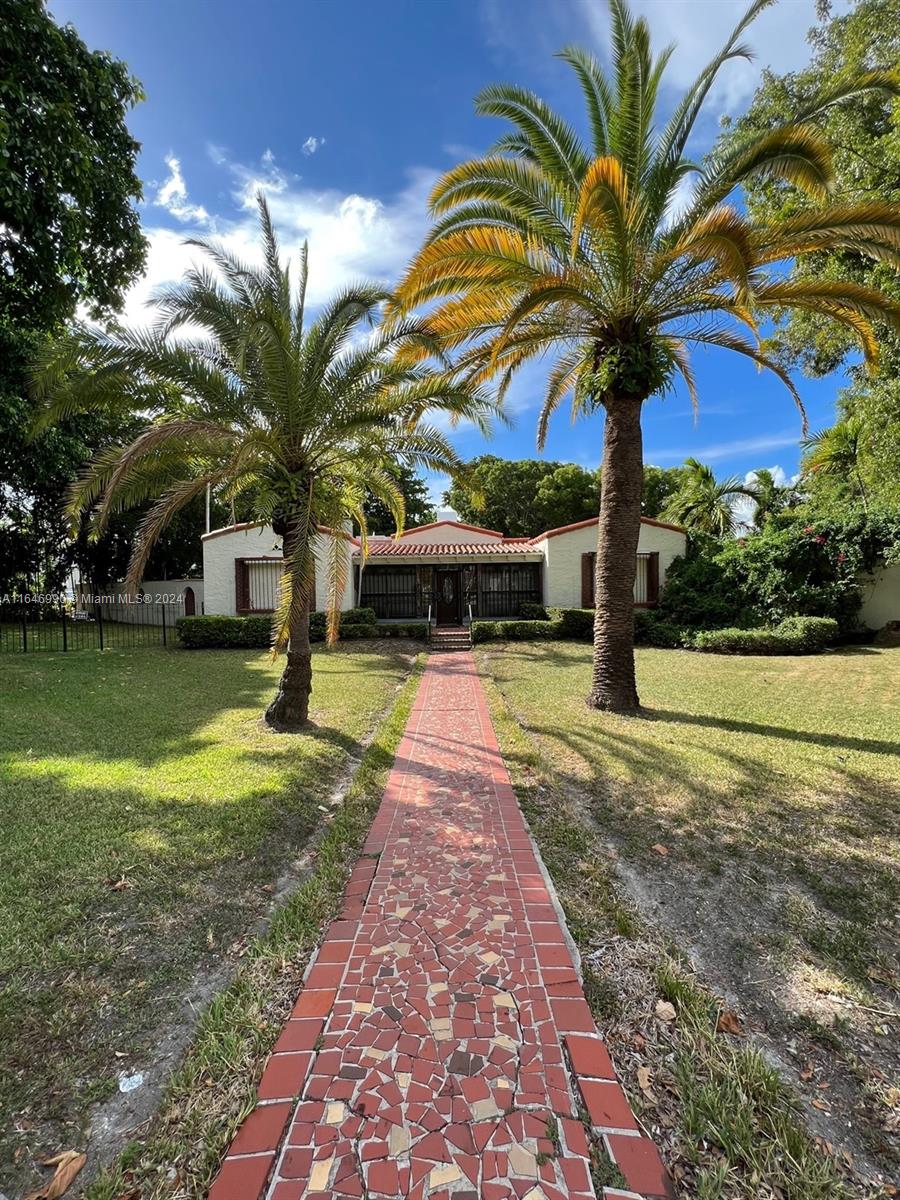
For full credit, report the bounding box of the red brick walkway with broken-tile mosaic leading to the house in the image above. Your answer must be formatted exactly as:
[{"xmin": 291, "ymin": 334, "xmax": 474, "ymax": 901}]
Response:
[{"xmin": 210, "ymin": 653, "xmax": 670, "ymax": 1200}]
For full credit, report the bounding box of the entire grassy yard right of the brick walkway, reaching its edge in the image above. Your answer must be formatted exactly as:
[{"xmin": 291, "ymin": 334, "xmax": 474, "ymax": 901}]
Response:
[{"xmin": 481, "ymin": 643, "xmax": 900, "ymax": 1200}]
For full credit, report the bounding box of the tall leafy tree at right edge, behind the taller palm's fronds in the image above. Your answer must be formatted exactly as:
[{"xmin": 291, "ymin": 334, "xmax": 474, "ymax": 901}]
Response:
[{"xmin": 720, "ymin": 0, "xmax": 900, "ymax": 509}]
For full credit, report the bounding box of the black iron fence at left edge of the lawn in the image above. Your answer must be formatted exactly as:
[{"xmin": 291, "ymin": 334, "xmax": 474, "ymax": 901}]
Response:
[{"xmin": 0, "ymin": 594, "xmax": 185, "ymax": 654}]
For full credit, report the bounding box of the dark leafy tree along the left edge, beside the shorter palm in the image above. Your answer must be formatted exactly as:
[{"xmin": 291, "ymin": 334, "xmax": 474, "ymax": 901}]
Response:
[{"xmin": 0, "ymin": 0, "xmax": 145, "ymax": 590}]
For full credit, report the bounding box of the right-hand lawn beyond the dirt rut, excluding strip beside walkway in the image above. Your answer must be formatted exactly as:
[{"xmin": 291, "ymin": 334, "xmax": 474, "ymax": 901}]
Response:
[{"xmin": 481, "ymin": 643, "xmax": 900, "ymax": 1194}]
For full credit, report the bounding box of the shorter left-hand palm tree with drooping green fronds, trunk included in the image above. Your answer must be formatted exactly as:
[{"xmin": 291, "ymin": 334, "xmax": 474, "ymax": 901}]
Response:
[{"xmin": 34, "ymin": 196, "xmax": 496, "ymax": 731}]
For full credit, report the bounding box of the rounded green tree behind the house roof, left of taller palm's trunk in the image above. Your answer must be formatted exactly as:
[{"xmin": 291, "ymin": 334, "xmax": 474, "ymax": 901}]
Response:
[{"xmin": 444, "ymin": 455, "xmax": 600, "ymax": 538}]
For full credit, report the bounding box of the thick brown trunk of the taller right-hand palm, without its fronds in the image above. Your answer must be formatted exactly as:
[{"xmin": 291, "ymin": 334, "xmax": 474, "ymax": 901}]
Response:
[{"xmin": 588, "ymin": 397, "xmax": 643, "ymax": 713}]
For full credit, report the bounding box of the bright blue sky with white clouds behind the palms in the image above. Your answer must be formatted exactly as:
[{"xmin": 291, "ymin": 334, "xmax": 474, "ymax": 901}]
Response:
[{"xmin": 50, "ymin": 0, "xmax": 854, "ymax": 504}]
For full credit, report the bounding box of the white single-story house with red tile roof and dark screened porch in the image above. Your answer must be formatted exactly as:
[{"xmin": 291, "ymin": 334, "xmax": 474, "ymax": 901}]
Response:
[{"xmin": 203, "ymin": 517, "xmax": 686, "ymax": 625}]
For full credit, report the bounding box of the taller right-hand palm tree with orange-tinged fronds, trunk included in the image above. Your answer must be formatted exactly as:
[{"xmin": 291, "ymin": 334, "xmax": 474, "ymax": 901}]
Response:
[{"xmin": 396, "ymin": 0, "xmax": 900, "ymax": 712}]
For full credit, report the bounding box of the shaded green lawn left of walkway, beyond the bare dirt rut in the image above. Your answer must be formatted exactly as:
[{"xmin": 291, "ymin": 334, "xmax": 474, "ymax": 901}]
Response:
[{"xmin": 0, "ymin": 649, "xmax": 409, "ymax": 1177}]
